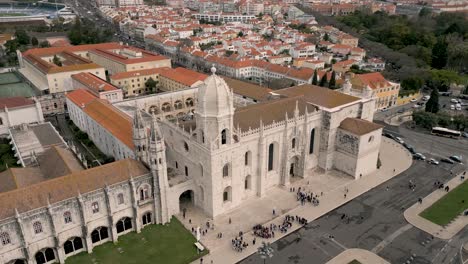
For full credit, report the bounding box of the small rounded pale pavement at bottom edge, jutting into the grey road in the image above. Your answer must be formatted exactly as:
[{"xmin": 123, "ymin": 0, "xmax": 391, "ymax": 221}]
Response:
[{"xmin": 327, "ymin": 248, "xmax": 390, "ymax": 264}]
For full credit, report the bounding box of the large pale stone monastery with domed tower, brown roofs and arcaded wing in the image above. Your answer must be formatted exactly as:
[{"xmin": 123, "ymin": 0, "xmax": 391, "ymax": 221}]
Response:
[{"xmin": 0, "ymin": 68, "xmax": 382, "ymax": 264}]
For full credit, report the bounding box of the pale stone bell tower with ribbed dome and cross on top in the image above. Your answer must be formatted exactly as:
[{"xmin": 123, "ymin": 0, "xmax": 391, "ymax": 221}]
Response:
[{"xmin": 195, "ymin": 66, "xmax": 234, "ymax": 149}]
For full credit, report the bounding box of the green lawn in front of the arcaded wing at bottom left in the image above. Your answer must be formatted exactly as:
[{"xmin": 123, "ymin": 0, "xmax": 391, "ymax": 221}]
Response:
[{"xmin": 65, "ymin": 217, "xmax": 208, "ymax": 264}]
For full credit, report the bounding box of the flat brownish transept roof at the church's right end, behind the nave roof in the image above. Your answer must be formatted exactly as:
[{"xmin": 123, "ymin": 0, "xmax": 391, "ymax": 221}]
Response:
[{"xmin": 274, "ymin": 84, "xmax": 360, "ymax": 108}]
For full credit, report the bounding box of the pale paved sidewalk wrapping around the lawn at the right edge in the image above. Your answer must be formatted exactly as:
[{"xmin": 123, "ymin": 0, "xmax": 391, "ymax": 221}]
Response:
[{"xmin": 404, "ymin": 172, "xmax": 468, "ymax": 239}]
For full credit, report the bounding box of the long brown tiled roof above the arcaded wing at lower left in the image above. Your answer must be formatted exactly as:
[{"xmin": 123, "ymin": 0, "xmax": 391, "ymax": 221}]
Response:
[{"xmin": 0, "ymin": 159, "xmax": 148, "ymax": 219}]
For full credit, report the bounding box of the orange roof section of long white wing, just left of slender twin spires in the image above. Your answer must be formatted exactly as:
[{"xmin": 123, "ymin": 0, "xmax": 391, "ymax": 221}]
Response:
[{"xmin": 84, "ymin": 99, "xmax": 135, "ymax": 149}]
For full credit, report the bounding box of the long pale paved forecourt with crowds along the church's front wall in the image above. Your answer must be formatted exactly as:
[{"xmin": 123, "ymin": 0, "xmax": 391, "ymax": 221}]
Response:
[{"xmin": 188, "ymin": 138, "xmax": 412, "ymax": 264}]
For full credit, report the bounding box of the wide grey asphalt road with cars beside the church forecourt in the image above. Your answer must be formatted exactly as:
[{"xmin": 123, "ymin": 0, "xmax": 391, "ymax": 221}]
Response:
[{"xmin": 241, "ymin": 128, "xmax": 468, "ymax": 264}]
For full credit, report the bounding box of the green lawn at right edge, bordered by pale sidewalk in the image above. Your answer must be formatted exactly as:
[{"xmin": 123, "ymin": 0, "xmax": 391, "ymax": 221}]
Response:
[{"xmin": 420, "ymin": 181, "xmax": 468, "ymax": 226}]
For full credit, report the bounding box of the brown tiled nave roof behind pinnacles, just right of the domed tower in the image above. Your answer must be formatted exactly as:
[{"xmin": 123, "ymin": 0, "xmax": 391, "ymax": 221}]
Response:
[{"xmin": 234, "ymin": 96, "xmax": 314, "ymax": 131}]
